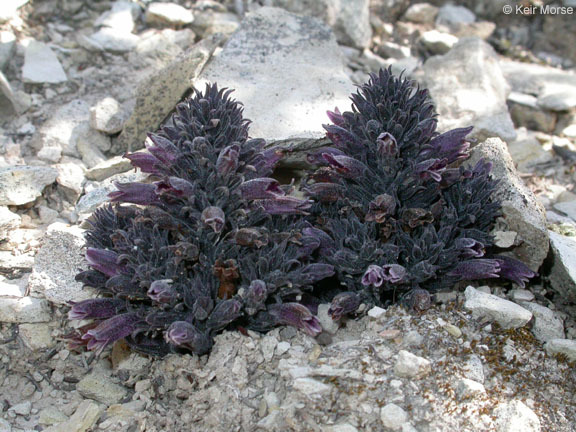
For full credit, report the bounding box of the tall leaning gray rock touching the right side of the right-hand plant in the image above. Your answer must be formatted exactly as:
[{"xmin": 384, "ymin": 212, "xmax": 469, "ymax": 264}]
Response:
[{"xmin": 468, "ymin": 138, "xmax": 548, "ymax": 271}]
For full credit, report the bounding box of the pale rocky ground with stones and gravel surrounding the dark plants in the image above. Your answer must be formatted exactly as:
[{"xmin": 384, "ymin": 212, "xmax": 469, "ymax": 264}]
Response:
[{"xmin": 0, "ymin": 0, "xmax": 576, "ymax": 432}]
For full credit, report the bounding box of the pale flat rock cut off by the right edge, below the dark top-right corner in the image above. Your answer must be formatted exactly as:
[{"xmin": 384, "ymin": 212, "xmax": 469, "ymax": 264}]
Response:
[{"xmin": 501, "ymin": 61, "xmax": 576, "ymax": 111}]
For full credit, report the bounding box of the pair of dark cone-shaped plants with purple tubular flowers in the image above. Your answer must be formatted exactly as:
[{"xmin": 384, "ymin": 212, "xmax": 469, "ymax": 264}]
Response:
[{"xmin": 69, "ymin": 71, "xmax": 533, "ymax": 355}]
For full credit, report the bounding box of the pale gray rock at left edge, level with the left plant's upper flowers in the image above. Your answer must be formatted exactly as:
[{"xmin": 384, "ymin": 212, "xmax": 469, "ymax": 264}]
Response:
[{"xmin": 0, "ymin": 165, "xmax": 58, "ymax": 205}]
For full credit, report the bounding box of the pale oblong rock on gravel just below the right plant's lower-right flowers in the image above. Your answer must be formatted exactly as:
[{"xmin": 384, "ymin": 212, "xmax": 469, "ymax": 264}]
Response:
[{"xmin": 464, "ymin": 286, "xmax": 532, "ymax": 329}]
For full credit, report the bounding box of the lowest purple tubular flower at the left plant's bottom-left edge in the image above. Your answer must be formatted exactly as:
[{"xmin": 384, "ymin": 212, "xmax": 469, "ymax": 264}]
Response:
[{"xmin": 82, "ymin": 313, "xmax": 142, "ymax": 355}]
